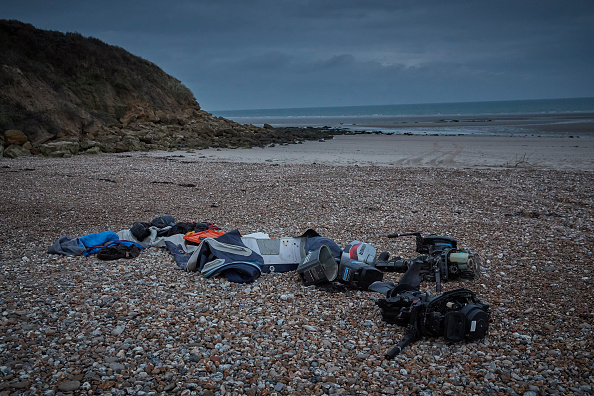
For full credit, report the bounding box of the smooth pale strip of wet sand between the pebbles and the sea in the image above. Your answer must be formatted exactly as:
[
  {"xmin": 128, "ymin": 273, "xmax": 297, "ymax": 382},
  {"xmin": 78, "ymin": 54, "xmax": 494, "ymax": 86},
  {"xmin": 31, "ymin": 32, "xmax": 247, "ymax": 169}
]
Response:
[{"xmin": 138, "ymin": 133, "xmax": 594, "ymax": 171}]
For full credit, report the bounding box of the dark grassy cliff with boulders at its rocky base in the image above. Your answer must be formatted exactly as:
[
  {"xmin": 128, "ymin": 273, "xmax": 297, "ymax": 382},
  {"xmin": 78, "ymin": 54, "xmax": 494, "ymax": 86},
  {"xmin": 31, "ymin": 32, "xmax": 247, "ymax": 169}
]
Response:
[{"xmin": 0, "ymin": 20, "xmax": 336, "ymax": 157}]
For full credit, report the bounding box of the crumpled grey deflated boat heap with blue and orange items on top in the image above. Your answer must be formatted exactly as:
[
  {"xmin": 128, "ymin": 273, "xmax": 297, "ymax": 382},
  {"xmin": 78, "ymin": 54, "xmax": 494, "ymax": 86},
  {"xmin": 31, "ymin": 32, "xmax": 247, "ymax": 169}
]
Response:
[{"xmin": 47, "ymin": 216, "xmax": 342, "ymax": 283}]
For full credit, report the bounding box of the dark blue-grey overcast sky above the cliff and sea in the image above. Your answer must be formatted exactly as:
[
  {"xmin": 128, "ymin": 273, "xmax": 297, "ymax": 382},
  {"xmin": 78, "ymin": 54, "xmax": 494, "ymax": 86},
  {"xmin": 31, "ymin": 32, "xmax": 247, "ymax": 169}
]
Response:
[{"xmin": 0, "ymin": 0, "xmax": 594, "ymax": 111}]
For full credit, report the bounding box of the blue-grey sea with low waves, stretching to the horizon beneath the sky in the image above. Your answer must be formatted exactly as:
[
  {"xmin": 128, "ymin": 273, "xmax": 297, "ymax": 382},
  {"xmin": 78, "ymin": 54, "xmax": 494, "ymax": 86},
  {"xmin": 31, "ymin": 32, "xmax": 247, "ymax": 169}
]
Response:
[{"xmin": 212, "ymin": 97, "xmax": 594, "ymax": 138}]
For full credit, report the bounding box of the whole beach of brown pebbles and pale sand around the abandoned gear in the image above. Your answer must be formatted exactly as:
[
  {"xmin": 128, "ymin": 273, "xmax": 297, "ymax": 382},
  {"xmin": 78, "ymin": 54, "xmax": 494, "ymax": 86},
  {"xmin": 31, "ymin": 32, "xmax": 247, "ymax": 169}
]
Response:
[{"xmin": 0, "ymin": 135, "xmax": 594, "ymax": 396}]
